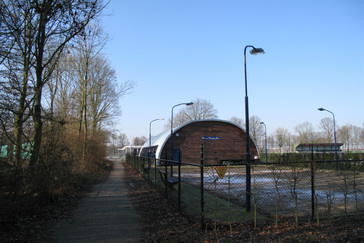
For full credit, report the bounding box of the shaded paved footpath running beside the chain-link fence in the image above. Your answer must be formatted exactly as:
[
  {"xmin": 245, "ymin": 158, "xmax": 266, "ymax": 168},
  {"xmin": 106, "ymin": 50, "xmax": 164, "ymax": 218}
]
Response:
[{"xmin": 44, "ymin": 159, "xmax": 142, "ymax": 243}]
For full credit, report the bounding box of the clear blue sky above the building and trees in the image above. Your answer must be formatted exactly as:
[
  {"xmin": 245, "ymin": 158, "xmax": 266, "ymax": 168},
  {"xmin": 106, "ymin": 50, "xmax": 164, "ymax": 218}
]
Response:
[{"xmin": 102, "ymin": 0, "xmax": 364, "ymax": 142}]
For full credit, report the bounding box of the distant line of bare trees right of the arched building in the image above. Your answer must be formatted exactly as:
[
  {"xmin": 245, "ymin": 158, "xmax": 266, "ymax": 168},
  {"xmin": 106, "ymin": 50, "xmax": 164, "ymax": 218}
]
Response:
[{"xmin": 230, "ymin": 116, "xmax": 364, "ymax": 153}]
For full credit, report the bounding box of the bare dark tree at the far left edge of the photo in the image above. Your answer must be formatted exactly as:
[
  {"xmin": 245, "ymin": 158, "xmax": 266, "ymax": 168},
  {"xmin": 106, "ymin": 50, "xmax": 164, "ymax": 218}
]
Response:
[{"xmin": 0, "ymin": 1, "xmax": 35, "ymax": 166}]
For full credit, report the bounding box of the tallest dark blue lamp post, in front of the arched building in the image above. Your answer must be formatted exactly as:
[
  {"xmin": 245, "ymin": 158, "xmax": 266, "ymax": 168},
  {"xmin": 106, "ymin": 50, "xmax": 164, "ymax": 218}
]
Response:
[{"xmin": 244, "ymin": 45, "xmax": 264, "ymax": 212}]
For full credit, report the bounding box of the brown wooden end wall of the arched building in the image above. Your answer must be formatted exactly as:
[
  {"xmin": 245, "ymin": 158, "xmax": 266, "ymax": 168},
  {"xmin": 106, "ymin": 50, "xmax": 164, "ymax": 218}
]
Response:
[{"xmin": 161, "ymin": 120, "xmax": 258, "ymax": 165}]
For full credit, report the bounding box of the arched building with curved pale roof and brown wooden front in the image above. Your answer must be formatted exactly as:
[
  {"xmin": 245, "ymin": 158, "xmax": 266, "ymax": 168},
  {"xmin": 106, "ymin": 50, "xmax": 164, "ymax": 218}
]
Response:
[{"xmin": 140, "ymin": 119, "xmax": 259, "ymax": 165}]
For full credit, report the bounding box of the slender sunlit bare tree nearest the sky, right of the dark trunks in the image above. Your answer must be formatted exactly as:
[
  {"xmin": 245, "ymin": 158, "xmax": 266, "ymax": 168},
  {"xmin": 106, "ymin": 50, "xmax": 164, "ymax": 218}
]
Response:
[{"xmin": 64, "ymin": 24, "xmax": 121, "ymax": 163}]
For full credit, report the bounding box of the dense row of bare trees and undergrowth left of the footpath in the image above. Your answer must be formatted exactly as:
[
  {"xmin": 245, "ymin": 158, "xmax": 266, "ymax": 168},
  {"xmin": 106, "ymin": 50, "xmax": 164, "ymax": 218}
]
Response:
[{"xmin": 0, "ymin": 0, "xmax": 133, "ymax": 203}]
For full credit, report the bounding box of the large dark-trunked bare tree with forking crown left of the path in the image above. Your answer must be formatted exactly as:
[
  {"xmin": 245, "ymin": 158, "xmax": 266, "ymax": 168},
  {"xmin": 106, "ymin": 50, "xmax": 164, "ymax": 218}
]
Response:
[{"xmin": 1, "ymin": 0, "xmax": 103, "ymax": 165}]
